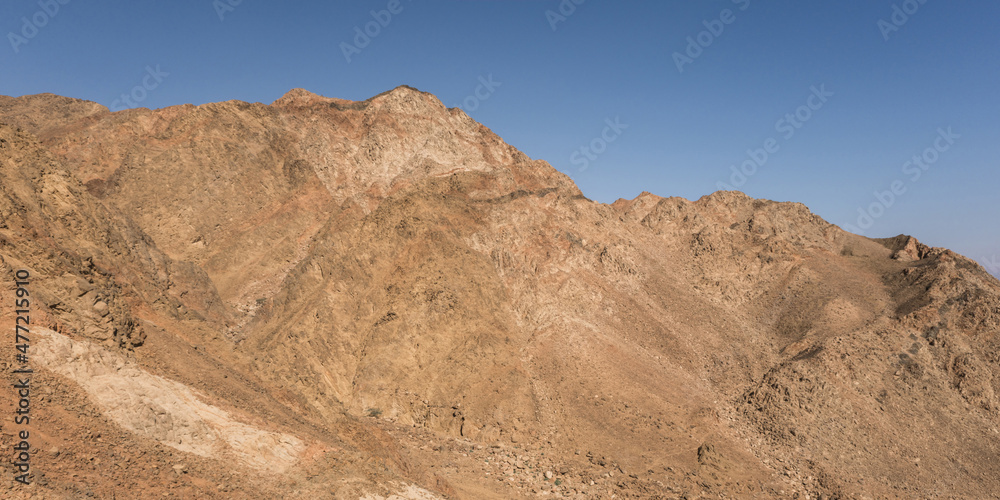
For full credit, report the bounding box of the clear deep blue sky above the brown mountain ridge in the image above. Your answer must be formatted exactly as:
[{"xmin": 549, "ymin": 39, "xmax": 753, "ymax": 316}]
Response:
[{"xmin": 0, "ymin": 0, "xmax": 1000, "ymax": 273}]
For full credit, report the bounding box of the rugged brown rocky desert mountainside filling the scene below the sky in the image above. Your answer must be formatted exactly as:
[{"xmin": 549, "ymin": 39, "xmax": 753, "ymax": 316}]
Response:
[{"xmin": 0, "ymin": 87, "xmax": 1000, "ymax": 498}]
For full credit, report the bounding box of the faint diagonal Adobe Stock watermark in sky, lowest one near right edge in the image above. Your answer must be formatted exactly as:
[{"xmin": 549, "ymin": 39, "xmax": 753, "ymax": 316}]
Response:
[{"xmin": 843, "ymin": 127, "xmax": 962, "ymax": 235}]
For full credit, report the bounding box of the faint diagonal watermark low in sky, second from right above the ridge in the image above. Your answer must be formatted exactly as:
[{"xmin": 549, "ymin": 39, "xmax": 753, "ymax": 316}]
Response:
[{"xmin": 715, "ymin": 84, "xmax": 833, "ymax": 191}]
